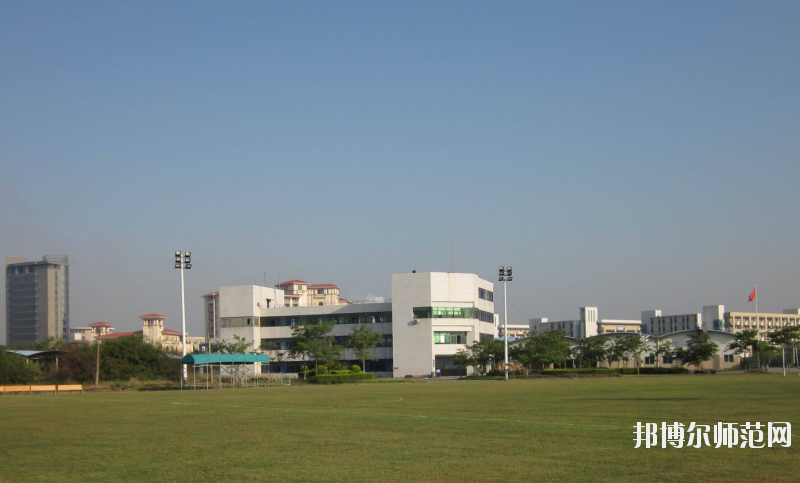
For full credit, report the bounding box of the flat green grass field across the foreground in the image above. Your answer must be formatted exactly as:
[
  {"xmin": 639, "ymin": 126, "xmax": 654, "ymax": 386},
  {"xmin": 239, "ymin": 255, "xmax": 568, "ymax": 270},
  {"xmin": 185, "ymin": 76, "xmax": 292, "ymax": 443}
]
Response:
[{"xmin": 0, "ymin": 374, "xmax": 800, "ymax": 483}]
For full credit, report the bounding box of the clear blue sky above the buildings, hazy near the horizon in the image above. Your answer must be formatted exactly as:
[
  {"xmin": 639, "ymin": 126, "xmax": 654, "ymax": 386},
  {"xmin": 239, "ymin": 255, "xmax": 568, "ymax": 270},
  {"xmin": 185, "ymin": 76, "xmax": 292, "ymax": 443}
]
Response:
[{"xmin": 0, "ymin": 1, "xmax": 800, "ymax": 337}]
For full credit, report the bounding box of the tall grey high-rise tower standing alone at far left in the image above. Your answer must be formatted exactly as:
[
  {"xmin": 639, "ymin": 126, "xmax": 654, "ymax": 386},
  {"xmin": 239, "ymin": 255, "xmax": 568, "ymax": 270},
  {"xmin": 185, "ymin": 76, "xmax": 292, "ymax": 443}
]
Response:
[{"xmin": 6, "ymin": 256, "xmax": 69, "ymax": 344}]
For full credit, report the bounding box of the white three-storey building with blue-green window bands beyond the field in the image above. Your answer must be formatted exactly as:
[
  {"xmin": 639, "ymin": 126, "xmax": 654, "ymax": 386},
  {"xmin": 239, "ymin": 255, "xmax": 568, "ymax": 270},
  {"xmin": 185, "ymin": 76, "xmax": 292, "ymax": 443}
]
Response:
[{"xmin": 219, "ymin": 272, "xmax": 497, "ymax": 377}]
